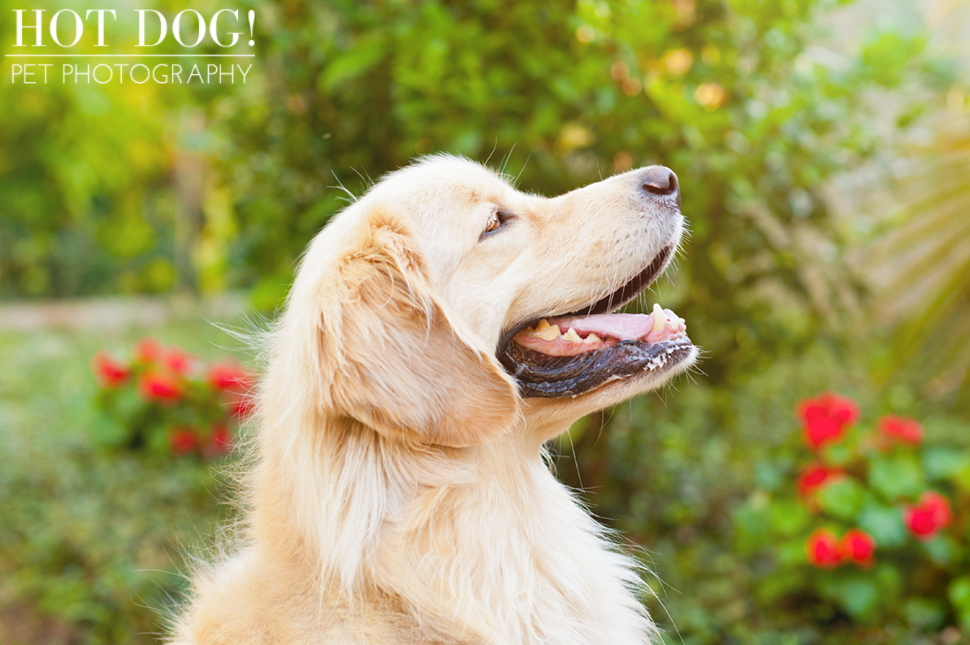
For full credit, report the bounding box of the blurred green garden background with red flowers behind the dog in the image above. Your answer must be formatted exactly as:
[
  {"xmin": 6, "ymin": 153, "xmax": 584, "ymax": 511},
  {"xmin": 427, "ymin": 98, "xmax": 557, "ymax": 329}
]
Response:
[{"xmin": 0, "ymin": 0, "xmax": 970, "ymax": 644}]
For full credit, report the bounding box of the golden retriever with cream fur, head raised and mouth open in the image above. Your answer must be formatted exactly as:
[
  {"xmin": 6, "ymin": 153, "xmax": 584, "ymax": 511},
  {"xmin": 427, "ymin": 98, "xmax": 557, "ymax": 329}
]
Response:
[{"xmin": 169, "ymin": 156, "xmax": 698, "ymax": 645}]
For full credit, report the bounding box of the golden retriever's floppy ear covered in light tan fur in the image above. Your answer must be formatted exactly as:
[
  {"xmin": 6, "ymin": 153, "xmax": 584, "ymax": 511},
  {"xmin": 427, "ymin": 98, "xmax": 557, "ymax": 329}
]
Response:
[{"xmin": 319, "ymin": 212, "xmax": 518, "ymax": 447}]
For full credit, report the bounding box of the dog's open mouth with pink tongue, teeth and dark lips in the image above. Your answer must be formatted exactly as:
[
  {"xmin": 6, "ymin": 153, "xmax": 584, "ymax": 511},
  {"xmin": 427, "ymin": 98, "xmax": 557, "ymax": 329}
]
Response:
[{"xmin": 498, "ymin": 246, "xmax": 693, "ymax": 398}]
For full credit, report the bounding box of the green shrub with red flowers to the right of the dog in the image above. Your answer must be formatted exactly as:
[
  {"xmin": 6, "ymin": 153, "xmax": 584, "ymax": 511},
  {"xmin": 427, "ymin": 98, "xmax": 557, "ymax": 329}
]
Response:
[{"xmin": 734, "ymin": 395, "xmax": 970, "ymax": 632}]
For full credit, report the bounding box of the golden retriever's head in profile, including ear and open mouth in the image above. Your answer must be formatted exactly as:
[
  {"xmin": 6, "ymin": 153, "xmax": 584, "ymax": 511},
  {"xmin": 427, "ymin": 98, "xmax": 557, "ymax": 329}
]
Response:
[{"xmin": 283, "ymin": 156, "xmax": 697, "ymax": 447}]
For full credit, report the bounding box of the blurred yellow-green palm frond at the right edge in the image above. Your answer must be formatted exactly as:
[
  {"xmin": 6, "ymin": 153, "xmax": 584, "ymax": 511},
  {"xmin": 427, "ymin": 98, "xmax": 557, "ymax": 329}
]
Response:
[{"xmin": 868, "ymin": 112, "xmax": 970, "ymax": 387}]
